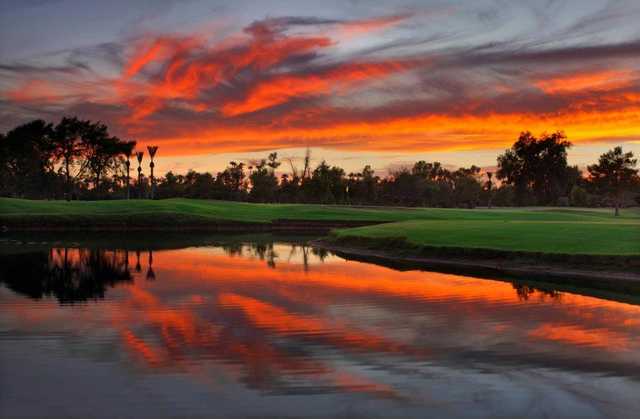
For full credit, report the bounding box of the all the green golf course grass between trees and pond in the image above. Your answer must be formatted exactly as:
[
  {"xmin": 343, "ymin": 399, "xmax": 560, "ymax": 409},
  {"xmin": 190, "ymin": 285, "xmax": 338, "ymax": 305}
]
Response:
[{"xmin": 0, "ymin": 198, "xmax": 640, "ymax": 255}]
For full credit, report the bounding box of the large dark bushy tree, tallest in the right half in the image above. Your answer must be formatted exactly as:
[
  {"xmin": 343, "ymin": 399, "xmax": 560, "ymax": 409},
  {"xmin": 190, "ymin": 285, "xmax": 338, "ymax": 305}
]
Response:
[{"xmin": 496, "ymin": 131, "xmax": 571, "ymax": 205}]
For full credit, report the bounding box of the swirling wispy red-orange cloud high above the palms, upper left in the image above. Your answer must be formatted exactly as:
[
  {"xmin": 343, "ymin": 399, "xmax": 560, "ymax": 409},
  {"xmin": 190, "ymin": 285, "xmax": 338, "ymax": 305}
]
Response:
[{"xmin": 119, "ymin": 30, "xmax": 331, "ymax": 123}]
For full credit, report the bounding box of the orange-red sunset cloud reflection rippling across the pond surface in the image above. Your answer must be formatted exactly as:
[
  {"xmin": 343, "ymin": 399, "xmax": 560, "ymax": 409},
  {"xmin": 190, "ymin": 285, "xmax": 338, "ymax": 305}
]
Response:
[{"xmin": 6, "ymin": 245, "xmax": 640, "ymax": 398}]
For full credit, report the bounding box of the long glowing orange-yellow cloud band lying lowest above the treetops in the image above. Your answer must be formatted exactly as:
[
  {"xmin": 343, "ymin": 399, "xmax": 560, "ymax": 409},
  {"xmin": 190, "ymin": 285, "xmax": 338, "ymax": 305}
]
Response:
[{"xmin": 137, "ymin": 104, "xmax": 640, "ymax": 155}]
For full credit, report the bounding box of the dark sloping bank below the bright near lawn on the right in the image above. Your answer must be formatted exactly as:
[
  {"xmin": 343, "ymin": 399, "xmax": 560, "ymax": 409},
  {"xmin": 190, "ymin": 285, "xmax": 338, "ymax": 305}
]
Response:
[{"xmin": 310, "ymin": 236, "xmax": 640, "ymax": 294}]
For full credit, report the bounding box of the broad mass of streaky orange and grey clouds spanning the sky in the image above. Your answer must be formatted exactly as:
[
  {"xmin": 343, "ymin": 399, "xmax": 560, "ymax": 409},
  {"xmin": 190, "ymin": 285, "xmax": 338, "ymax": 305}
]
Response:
[{"xmin": 0, "ymin": 4, "xmax": 640, "ymax": 159}]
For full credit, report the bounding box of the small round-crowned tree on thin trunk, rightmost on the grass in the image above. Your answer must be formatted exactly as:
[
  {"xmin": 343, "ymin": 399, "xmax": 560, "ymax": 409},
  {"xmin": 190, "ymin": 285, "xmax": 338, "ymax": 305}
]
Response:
[{"xmin": 587, "ymin": 147, "xmax": 638, "ymax": 216}]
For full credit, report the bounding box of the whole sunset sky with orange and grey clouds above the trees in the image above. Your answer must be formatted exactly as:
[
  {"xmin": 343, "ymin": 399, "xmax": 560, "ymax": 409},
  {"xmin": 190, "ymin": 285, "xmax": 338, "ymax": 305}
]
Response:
[{"xmin": 0, "ymin": 0, "xmax": 640, "ymax": 172}]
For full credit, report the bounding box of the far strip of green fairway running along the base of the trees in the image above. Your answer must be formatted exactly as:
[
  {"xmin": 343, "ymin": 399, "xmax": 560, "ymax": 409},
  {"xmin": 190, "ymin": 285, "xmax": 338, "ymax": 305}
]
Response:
[{"xmin": 0, "ymin": 198, "xmax": 640, "ymax": 222}]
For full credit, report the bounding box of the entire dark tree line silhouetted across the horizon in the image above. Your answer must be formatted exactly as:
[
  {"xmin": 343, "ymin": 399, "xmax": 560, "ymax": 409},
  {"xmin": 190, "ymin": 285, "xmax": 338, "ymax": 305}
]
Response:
[{"xmin": 0, "ymin": 117, "xmax": 640, "ymax": 212}]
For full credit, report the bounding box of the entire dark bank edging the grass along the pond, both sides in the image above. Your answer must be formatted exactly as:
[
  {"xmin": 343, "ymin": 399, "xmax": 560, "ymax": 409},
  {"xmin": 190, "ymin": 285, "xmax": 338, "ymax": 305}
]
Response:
[{"xmin": 5, "ymin": 220, "xmax": 640, "ymax": 295}]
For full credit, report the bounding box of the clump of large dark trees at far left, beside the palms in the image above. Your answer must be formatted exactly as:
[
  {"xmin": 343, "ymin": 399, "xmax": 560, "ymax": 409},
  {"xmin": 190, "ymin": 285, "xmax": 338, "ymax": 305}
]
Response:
[{"xmin": 0, "ymin": 117, "xmax": 136, "ymax": 199}]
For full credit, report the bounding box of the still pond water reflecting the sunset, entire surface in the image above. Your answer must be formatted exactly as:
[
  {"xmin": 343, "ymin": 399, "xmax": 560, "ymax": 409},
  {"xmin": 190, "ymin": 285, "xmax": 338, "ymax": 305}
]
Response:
[{"xmin": 0, "ymin": 237, "xmax": 640, "ymax": 418}]
